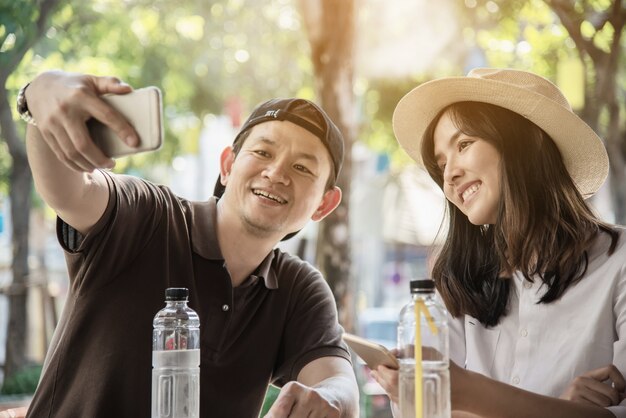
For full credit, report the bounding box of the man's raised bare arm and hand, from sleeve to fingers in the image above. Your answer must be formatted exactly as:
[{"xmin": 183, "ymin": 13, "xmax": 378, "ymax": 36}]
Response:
[{"xmin": 26, "ymin": 71, "xmax": 137, "ymax": 234}]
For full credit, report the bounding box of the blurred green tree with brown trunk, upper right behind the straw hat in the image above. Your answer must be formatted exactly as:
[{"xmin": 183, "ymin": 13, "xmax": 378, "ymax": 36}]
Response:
[{"xmin": 462, "ymin": 0, "xmax": 626, "ymax": 224}]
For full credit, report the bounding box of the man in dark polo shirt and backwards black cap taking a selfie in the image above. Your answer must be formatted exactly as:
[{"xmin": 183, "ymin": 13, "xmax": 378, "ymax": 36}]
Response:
[{"xmin": 18, "ymin": 72, "xmax": 358, "ymax": 418}]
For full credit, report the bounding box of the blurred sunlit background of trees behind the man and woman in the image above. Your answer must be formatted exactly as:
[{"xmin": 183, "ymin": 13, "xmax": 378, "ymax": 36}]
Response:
[{"xmin": 0, "ymin": 0, "xmax": 626, "ymax": 417}]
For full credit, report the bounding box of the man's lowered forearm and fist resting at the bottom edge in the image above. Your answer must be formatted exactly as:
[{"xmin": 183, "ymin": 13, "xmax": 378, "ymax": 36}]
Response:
[{"xmin": 266, "ymin": 357, "xmax": 359, "ymax": 418}]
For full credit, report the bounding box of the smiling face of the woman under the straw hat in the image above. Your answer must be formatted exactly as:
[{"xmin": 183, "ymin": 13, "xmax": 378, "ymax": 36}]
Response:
[{"xmin": 434, "ymin": 112, "xmax": 502, "ymax": 225}]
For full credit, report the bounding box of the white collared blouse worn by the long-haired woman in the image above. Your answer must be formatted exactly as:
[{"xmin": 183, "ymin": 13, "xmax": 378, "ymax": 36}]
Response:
[{"xmin": 450, "ymin": 229, "xmax": 626, "ymax": 418}]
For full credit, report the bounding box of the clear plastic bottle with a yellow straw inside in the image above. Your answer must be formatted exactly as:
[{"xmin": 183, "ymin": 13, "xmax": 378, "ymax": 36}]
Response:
[{"xmin": 398, "ymin": 279, "xmax": 451, "ymax": 418}]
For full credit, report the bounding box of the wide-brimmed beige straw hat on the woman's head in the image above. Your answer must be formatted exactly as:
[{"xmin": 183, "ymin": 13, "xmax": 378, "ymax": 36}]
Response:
[{"xmin": 393, "ymin": 68, "xmax": 609, "ymax": 197}]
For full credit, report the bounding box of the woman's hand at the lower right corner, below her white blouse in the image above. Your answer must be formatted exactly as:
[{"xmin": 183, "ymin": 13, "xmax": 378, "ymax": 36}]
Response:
[{"xmin": 560, "ymin": 364, "xmax": 626, "ymax": 407}]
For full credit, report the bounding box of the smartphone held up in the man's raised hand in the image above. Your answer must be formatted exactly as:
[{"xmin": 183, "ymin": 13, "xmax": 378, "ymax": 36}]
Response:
[{"xmin": 87, "ymin": 86, "xmax": 163, "ymax": 158}]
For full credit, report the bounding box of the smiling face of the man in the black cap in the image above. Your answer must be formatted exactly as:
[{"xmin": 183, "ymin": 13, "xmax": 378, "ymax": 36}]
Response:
[{"xmin": 222, "ymin": 121, "xmax": 333, "ymax": 239}]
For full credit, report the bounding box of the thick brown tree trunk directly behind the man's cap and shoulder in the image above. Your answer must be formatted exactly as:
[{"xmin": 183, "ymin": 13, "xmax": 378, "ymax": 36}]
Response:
[{"xmin": 300, "ymin": 0, "xmax": 356, "ymax": 329}]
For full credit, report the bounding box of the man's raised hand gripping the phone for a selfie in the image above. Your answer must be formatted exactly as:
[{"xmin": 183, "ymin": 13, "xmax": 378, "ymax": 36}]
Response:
[{"xmin": 25, "ymin": 71, "xmax": 160, "ymax": 172}]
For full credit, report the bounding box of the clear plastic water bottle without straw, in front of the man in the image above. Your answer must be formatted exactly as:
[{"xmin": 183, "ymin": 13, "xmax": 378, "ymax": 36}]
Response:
[{"xmin": 152, "ymin": 287, "xmax": 200, "ymax": 418}]
